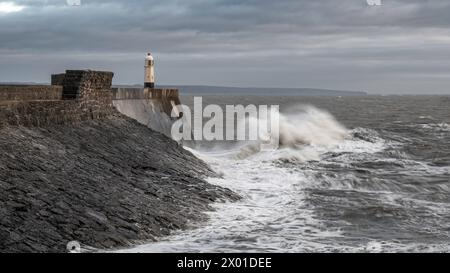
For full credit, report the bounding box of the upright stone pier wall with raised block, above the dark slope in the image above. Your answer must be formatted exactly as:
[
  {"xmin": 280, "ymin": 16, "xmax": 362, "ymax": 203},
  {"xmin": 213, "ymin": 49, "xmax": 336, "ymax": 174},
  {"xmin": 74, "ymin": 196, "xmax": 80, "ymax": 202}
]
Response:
[{"xmin": 0, "ymin": 70, "xmax": 180, "ymax": 136}]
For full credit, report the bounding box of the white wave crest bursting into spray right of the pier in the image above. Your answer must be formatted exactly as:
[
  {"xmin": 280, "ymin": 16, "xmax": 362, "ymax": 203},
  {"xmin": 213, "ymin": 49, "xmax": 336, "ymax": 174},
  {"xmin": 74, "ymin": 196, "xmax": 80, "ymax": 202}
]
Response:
[{"xmin": 235, "ymin": 105, "xmax": 370, "ymax": 159}]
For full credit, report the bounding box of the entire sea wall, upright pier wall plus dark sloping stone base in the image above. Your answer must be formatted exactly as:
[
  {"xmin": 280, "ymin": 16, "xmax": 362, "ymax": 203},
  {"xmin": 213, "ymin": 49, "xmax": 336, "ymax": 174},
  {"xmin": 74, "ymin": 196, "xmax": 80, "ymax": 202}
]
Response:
[{"xmin": 0, "ymin": 70, "xmax": 239, "ymax": 252}]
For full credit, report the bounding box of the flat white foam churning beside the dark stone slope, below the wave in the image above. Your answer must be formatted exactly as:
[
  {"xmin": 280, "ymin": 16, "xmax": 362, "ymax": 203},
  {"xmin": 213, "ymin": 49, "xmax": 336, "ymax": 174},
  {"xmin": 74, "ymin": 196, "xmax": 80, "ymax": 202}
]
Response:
[{"xmin": 117, "ymin": 146, "xmax": 340, "ymax": 252}]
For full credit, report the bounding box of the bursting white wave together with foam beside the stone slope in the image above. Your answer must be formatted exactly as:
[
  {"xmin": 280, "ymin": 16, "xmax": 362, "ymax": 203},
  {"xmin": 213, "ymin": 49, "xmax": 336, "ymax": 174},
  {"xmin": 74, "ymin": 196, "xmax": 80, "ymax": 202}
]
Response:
[{"xmin": 117, "ymin": 106, "xmax": 358, "ymax": 252}]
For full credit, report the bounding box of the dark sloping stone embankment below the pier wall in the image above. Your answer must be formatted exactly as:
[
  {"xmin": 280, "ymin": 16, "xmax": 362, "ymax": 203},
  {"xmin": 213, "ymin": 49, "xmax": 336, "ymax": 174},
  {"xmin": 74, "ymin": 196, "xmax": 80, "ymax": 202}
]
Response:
[{"xmin": 0, "ymin": 113, "xmax": 239, "ymax": 252}]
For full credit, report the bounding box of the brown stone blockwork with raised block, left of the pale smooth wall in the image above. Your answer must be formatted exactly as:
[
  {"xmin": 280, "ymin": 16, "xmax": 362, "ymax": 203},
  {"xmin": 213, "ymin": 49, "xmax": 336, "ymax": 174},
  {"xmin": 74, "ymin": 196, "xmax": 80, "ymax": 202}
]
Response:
[{"xmin": 0, "ymin": 70, "xmax": 115, "ymax": 126}]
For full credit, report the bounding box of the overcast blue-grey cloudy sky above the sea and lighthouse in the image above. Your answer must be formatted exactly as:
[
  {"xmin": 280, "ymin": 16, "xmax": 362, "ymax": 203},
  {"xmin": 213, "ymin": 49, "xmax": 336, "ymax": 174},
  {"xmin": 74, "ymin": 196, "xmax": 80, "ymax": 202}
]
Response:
[{"xmin": 0, "ymin": 0, "xmax": 450, "ymax": 94}]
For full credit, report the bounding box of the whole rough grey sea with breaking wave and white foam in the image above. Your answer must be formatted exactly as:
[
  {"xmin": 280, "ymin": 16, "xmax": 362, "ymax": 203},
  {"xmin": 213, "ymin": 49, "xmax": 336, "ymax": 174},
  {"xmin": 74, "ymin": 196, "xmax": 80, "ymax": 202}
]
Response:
[{"xmin": 118, "ymin": 95, "xmax": 450, "ymax": 252}]
